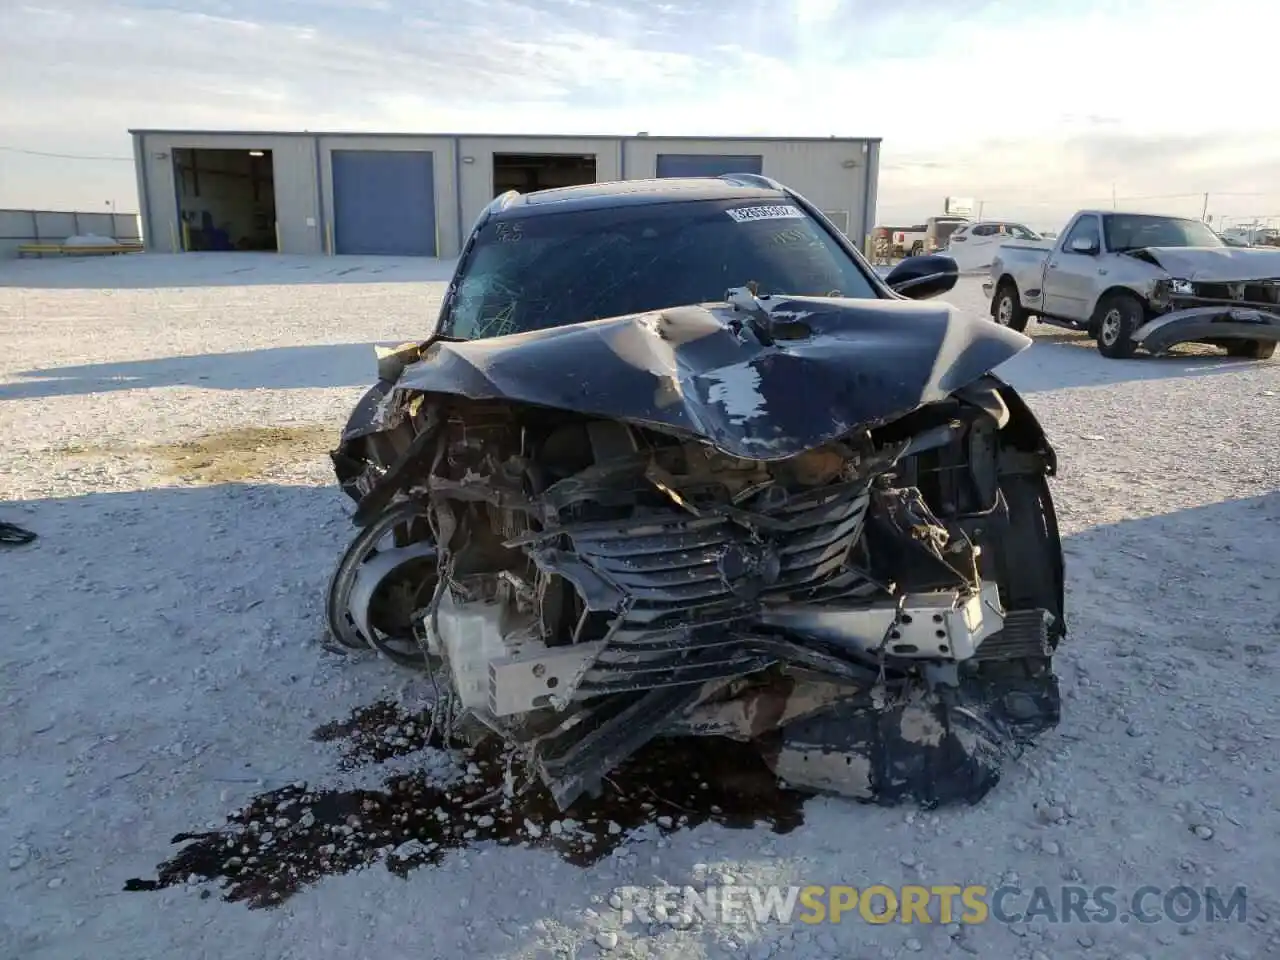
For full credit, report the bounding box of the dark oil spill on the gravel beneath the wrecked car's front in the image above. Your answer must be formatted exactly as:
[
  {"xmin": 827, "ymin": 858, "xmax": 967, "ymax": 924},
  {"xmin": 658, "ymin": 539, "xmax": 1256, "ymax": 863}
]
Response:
[{"xmin": 124, "ymin": 703, "xmax": 809, "ymax": 908}]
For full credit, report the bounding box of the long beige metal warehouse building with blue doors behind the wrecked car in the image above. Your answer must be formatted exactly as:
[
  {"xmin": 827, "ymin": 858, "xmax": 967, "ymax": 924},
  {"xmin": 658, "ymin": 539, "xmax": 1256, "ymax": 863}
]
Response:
[{"xmin": 129, "ymin": 129, "xmax": 879, "ymax": 257}]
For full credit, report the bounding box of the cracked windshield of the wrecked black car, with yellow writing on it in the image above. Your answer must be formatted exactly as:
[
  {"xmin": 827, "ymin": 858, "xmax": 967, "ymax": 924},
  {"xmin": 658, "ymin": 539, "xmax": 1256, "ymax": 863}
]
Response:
[{"xmin": 439, "ymin": 200, "xmax": 878, "ymax": 339}]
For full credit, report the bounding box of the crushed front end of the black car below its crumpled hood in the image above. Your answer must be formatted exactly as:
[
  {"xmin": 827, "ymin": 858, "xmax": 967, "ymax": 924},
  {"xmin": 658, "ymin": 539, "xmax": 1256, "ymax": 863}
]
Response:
[{"xmin": 329, "ymin": 293, "xmax": 1065, "ymax": 809}]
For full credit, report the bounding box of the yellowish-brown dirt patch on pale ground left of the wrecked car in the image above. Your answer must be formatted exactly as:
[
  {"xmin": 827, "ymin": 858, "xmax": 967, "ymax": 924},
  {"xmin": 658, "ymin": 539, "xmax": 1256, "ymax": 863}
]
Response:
[{"xmin": 63, "ymin": 425, "xmax": 338, "ymax": 484}]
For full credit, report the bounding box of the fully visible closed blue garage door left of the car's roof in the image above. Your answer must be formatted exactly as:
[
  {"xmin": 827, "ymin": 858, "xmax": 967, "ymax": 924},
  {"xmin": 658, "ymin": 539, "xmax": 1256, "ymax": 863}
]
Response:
[{"xmin": 332, "ymin": 150, "xmax": 435, "ymax": 257}]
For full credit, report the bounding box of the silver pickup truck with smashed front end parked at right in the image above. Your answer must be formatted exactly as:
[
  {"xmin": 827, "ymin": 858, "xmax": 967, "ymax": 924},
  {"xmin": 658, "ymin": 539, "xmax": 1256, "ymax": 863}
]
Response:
[{"xmin": 982, "ymin": 210, "xmax": 1280, "ymax": 360}]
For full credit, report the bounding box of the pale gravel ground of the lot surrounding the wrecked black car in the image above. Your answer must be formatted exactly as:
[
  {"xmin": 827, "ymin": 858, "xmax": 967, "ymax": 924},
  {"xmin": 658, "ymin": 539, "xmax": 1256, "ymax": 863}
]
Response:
[{"xmin": 0, "ymin": 255, "xmax": 1280, "ymax": 960}]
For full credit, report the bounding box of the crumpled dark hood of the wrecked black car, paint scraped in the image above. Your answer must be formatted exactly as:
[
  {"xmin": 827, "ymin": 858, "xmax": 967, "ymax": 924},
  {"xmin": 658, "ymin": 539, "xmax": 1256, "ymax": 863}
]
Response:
[{"xmin": 396, "ymin": 297, "xmax": 1030, "ymax": 460}]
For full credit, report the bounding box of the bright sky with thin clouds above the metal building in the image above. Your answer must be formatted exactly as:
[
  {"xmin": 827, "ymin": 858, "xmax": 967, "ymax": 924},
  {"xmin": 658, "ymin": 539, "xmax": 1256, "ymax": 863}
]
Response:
[{"xmin": 0, "ymin": 0, "xmax": 1280, "ymax": 228}]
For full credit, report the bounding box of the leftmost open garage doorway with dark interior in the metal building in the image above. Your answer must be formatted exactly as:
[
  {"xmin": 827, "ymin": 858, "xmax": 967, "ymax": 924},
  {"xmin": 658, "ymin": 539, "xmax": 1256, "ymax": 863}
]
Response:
[{"xmin": 173, "ymin": 147, "xmax": 279, "ymax": 252}]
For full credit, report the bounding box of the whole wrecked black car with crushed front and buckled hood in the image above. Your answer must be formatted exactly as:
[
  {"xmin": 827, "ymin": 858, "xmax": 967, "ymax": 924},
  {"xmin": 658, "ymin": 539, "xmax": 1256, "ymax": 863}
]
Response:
[{"xmin": 328, "ymin": 174, "xmax": 1065, "ymax": 809}]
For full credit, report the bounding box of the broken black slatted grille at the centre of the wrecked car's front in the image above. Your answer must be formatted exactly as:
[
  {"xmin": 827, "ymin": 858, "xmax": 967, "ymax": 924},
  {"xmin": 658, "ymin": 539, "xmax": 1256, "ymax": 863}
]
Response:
[{"xmin": 534, "ymin": 481, "xmax": 869, "ymax": 699}]
